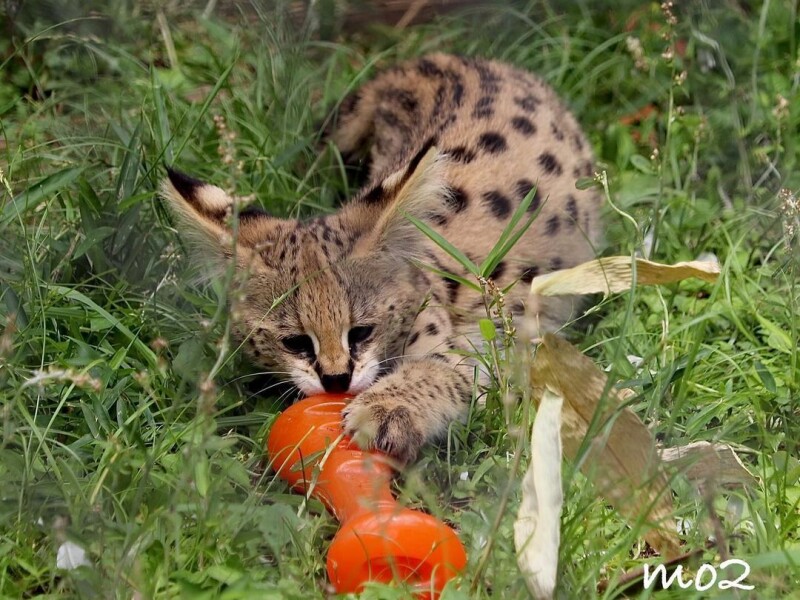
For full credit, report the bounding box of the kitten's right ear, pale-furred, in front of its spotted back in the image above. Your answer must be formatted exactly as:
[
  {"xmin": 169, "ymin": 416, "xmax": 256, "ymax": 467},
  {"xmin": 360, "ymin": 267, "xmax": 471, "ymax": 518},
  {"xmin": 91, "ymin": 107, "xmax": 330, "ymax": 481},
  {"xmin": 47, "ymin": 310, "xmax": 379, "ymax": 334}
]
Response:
[{"xmin": 354, "ymin": 143, "xmax": 449, "ymax": 258}]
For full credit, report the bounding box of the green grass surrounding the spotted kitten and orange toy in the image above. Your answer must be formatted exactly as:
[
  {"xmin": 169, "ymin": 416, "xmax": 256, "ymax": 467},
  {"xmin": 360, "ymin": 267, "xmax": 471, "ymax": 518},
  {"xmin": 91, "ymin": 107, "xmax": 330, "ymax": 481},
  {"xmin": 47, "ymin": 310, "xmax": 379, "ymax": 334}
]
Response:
[{"xmin": 0, "ymin": 0, "xmax": 800, "ymax": 599}]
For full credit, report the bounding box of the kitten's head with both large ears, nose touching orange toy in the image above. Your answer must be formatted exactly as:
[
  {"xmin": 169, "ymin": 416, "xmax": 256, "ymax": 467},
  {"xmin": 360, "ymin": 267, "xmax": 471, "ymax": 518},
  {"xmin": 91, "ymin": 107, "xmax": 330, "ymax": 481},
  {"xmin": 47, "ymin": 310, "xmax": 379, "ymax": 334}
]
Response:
[{"xmin": 162, "ymin": 148, "xmax": 447, "ymax": 394}]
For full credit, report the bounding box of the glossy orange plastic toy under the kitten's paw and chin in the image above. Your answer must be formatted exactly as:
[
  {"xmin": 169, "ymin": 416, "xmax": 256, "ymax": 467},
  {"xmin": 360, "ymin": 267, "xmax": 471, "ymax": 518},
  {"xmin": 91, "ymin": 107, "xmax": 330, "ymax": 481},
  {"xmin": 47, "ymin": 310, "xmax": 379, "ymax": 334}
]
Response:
[{"xmin": 267, "ymin": 394, "xmax": 467, "ymax": 598}]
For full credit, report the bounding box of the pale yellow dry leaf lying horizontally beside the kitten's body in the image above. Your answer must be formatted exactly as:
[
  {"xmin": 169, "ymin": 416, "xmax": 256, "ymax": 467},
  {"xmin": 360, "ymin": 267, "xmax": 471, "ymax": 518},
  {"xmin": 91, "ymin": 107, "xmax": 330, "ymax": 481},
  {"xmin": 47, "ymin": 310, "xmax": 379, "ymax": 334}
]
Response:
[{"xmin": 530, "ymin": 256, "xmax": 719, "ymax": 296}]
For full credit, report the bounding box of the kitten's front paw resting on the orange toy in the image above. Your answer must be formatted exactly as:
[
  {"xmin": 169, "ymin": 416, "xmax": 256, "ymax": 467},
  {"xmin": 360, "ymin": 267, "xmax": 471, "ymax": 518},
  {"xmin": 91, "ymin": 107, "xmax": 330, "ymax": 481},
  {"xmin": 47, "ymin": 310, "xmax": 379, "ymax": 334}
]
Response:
[{"xmin": 342, "ymin": 390, "xmax": 425, "ymax": 463}]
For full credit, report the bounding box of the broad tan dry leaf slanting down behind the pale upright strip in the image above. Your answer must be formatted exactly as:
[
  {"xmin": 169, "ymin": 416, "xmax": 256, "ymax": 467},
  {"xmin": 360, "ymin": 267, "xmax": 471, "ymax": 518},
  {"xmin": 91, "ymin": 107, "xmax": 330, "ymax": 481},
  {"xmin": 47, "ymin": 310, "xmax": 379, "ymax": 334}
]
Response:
[{"xmin": 530, "ymin": 334, "xmax": 680, "ymax": 558}]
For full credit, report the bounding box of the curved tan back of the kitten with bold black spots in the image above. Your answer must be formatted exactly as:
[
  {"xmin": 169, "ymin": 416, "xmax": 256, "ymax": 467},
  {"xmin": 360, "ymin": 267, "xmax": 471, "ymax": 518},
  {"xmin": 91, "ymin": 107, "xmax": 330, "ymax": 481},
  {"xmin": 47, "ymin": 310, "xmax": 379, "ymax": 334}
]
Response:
[{"xmin": 331, "ymin": 54, "xmax": 601, "ymax": 328}]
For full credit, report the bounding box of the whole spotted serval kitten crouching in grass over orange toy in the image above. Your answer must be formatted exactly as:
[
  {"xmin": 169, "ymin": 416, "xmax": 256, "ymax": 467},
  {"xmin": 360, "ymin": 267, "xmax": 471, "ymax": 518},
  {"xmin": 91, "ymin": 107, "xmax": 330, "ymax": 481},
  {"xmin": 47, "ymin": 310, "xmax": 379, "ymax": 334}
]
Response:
[{"xmin": 163, "ymin": 54, "xmax": 601, "ymax": 461}]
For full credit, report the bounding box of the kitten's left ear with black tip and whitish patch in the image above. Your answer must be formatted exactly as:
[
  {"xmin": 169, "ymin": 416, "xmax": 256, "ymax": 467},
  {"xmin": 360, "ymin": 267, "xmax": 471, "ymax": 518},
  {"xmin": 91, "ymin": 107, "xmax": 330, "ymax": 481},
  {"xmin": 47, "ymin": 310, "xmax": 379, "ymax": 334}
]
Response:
[{"xmin": 161, "ymin": 168, "xmax": 269, "ymax": 272}]
